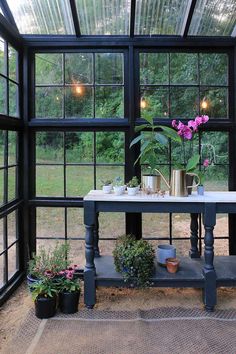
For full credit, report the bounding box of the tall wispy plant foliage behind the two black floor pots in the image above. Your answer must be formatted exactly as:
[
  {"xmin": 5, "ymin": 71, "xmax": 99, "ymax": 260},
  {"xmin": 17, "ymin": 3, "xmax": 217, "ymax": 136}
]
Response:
[{"xmin": 28, "ymin": 243, "xmax": 70, "ymax": 279}]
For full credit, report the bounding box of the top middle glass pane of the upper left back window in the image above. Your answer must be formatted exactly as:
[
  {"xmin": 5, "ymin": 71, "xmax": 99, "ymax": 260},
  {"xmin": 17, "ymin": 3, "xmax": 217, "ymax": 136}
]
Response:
[{"xmin": 65, "ymin": 53, "xmax": 93, "ymax": 84}]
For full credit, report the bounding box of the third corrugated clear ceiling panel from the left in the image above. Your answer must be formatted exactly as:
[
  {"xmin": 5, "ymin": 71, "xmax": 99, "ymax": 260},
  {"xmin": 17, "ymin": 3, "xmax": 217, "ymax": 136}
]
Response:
[{"xmin": 135, "ymin": 0, "xmax": 188, "ymax": 35}]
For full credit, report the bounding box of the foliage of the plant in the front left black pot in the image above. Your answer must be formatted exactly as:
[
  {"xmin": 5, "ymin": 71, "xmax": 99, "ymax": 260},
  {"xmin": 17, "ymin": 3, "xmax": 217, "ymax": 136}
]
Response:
[{"xmin": 29, "ymin": 276, "xmax": 58, "ymax": 301}]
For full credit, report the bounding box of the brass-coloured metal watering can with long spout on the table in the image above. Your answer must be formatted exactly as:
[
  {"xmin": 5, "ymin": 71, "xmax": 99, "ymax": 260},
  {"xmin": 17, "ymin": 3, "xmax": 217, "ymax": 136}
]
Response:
[{"xmin": 156, "ymin": 169, "xmax": 200, "ymax": 197}]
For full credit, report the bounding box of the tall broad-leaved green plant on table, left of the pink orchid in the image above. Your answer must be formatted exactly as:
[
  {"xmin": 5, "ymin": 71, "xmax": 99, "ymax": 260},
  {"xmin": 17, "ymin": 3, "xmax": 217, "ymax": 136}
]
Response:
[{"xmin": 130, "ymin": 112, "xmax": 181, "ymax": 174}]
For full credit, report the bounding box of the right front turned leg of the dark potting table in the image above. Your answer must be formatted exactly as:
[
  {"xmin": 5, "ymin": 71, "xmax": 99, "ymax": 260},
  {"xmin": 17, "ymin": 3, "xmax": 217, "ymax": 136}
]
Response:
[{"xmin": 203, "ymin": 204, "xmax": 216, "ymax": 311}]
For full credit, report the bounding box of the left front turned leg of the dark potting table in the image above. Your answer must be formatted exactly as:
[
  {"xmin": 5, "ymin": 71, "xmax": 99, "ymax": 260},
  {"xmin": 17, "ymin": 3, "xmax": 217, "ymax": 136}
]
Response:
[{"xmin": 84, "ymin": 202, "xmax": 96, "ymax": 308}]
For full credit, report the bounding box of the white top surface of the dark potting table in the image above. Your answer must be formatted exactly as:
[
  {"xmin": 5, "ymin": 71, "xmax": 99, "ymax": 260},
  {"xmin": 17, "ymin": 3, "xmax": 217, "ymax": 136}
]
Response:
[{"xmin": 84, "ymin": 190, "xmax": 236, "ymax": 203}]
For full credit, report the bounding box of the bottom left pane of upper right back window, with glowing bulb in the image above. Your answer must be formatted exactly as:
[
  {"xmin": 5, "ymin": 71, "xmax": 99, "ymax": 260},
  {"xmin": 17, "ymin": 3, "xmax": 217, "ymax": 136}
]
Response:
[{"xmin": 140, "ymin": 87, "xmax": 169, "ymax": 118}]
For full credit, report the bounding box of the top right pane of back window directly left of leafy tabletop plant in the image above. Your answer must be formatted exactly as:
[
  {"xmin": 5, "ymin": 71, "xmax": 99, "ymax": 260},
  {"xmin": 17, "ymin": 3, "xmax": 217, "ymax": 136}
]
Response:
[{"xmin": 96, "ymin": 132, "xmax": 125, "ymax": 163}]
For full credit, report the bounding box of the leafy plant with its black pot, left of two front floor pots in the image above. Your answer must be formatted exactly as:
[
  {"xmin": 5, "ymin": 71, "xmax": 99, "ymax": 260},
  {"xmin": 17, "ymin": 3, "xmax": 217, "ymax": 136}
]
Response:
[{"xmin": 30, "ymin": 276, "xmax": 58, "ymax": 318}]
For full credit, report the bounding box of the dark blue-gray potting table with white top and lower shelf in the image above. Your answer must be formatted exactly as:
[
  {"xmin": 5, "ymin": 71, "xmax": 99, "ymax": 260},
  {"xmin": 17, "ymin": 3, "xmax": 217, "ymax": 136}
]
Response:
[{"xmin": 84, "ymin": 190, "xmax": 236, "ymax": 310}]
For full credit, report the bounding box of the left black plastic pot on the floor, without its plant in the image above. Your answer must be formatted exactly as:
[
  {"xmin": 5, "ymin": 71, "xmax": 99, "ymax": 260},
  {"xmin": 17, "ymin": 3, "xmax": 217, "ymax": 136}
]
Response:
[{"xmin": 34, "ymin": 296, "xmax": 57, "ymax": 318}]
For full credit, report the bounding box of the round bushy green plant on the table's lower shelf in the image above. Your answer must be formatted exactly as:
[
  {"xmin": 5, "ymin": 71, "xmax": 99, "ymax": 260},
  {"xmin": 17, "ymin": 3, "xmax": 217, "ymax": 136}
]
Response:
[{"xmin": 113, "ymin": 235, "xmax": 155, "ymax": 288}]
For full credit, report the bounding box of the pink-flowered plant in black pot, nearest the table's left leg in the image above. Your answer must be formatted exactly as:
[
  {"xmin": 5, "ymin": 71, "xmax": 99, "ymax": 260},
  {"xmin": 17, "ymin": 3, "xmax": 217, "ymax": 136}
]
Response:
[{"xmin": 58, "ymin": 268, "xmax": 80, "ymax": 314}]
